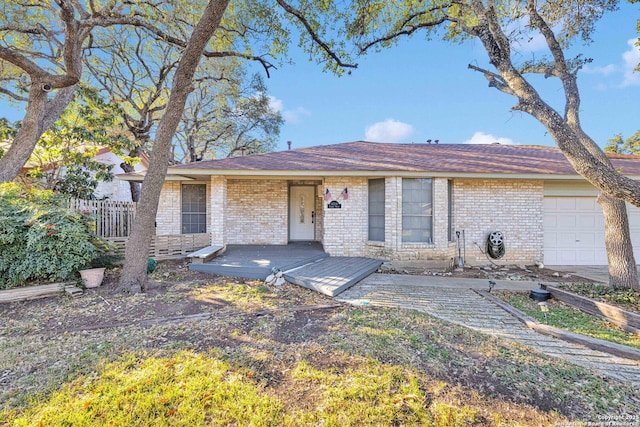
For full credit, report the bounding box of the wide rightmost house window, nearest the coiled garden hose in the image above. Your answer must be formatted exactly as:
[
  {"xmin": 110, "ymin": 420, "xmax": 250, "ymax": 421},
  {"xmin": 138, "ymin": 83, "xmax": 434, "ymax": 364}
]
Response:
[{"xmin": 402, "ymin": 178, "xmax": 433, "ymax": 243}]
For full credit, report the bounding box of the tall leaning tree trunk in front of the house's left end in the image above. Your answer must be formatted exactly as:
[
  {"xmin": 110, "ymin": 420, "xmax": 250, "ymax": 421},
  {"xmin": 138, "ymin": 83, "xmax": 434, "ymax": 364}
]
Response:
[{"xmin": 120, "ymin": 0, "xmax": 229, "ymax": 293}]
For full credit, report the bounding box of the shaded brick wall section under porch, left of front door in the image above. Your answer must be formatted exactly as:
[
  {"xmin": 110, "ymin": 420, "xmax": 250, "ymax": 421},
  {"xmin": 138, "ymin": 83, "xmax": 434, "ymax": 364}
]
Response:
[{"xmin": 225, "ymin": 179, "xmax": 289, "ymax": 245}]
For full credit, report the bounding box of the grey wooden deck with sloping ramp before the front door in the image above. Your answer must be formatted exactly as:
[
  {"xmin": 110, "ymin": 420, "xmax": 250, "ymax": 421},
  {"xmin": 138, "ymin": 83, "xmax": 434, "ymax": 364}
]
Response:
[{"xmin": 189, "ymin": 242, "xmax": 382, "ymax": 296}]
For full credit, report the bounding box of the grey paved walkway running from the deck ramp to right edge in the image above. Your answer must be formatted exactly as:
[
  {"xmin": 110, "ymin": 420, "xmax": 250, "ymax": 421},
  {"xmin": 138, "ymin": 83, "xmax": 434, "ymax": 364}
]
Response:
[{"xmin": 337, "ymin": 274, "xmax": 640, "ymax": 387}]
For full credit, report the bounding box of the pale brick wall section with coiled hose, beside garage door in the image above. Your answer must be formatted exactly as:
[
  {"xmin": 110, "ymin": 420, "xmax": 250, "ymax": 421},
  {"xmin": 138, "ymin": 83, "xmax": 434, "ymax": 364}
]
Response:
[{"xmin": 453, "ymin": 179, "xmax": 544, "ymax": 264}]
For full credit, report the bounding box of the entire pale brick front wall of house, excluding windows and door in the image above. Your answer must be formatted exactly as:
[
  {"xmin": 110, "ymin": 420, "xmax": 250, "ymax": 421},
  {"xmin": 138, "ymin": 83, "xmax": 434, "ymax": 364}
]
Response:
[{"xmin": 156, "ymin": 176, "xmax": 543, "ymax": 264}]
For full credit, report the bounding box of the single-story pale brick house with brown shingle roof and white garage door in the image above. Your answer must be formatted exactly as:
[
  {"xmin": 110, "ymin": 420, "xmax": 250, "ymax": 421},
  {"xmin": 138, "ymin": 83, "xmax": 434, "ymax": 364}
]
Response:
[{"xmin": 122, "ymin": 142, "xmax": 640, "ymax": 265}]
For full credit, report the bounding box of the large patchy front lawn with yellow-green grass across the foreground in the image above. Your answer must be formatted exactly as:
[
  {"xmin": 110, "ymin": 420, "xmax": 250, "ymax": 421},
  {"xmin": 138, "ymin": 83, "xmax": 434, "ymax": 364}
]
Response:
[{"xmin": 0, "ymin": 265, "xmax": 640, "ymax": 427}]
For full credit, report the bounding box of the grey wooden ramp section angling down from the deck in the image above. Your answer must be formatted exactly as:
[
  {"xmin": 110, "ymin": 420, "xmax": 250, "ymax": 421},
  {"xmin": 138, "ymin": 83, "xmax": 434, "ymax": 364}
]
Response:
[{"xmin": 284, "ymin": 257, "xmax": 382, "ymax": 297}]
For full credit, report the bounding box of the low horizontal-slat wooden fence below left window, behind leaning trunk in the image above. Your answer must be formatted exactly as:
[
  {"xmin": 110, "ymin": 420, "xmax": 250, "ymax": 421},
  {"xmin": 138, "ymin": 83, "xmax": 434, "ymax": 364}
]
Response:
[{"xmin": 104, "ymin": 233, "xmax": 211, "ymax": 259}]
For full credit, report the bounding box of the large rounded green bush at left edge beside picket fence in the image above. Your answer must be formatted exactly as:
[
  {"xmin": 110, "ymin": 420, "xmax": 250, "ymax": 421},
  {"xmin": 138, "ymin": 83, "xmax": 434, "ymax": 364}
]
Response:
[{"xmin": 0, "ymin": 184, "xmax": 100, "ymax": 289}]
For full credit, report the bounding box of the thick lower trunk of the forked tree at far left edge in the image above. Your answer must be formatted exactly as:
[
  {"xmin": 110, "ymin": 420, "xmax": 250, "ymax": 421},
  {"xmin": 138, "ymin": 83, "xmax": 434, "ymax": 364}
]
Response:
[{"xmin": 0, "ymin": 84, "xmax": 76, "ymax": 183}]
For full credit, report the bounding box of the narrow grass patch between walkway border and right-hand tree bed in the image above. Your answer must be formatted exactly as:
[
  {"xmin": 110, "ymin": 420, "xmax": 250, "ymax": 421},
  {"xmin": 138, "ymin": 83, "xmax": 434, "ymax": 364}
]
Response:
[{"xmin": 496, "ymin": 291, "xmax": 640, "ymax": 349}]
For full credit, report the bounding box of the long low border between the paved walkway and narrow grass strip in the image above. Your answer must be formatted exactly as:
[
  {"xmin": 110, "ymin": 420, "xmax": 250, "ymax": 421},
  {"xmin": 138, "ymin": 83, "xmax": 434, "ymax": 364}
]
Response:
[{"xmin": 473, "ymin": 289, "xmax": 640, "ymax": 360}]
